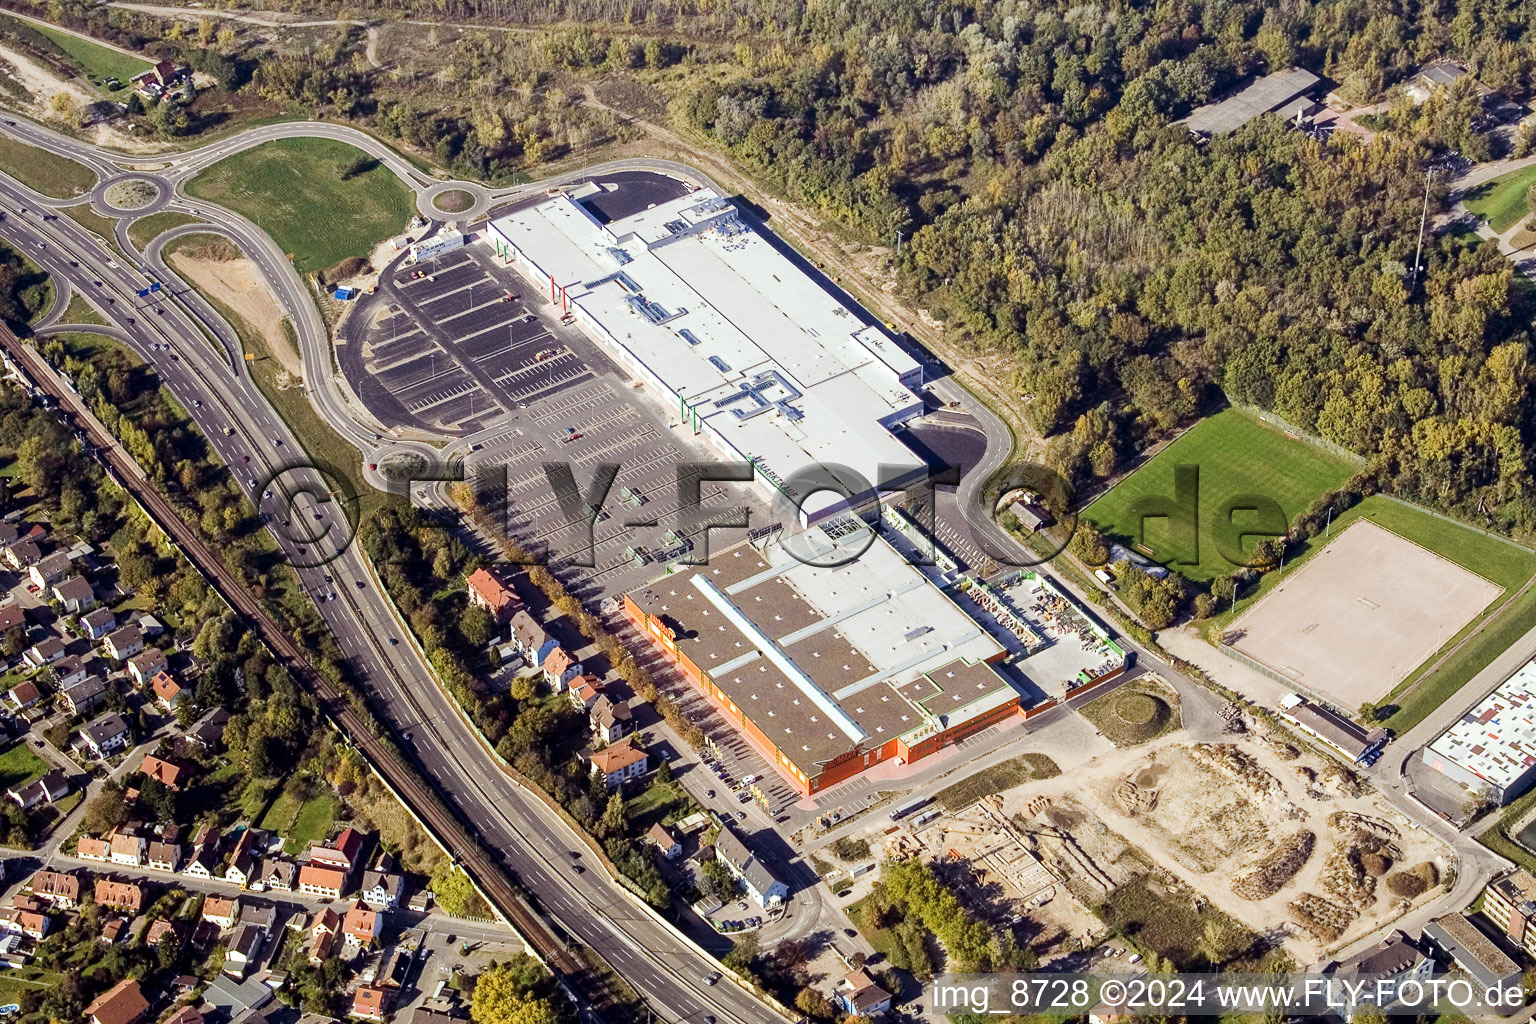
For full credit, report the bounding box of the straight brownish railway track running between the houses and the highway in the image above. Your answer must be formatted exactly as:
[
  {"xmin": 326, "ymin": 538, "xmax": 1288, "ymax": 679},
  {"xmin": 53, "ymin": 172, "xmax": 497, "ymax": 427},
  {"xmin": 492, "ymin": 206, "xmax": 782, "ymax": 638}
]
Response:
[{"xmin": 0, "ymin": 324, "xmax": 592, "ymax": 1009}]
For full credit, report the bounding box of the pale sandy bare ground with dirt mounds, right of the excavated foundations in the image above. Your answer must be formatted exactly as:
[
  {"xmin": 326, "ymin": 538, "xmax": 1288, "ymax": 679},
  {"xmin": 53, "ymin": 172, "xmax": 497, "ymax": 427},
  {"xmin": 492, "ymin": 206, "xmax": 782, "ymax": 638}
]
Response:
[{"xmin": 1003, "ymin": 722, "xmax": 1450, "ymax": 963}]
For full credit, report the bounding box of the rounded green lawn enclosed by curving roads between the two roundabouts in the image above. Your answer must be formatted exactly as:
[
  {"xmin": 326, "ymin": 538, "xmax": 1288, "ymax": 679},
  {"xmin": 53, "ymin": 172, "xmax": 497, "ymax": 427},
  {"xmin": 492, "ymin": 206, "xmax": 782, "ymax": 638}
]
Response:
[{"xmin": 187, "ymin": 138, "xmax": 416, "ymax": 272}]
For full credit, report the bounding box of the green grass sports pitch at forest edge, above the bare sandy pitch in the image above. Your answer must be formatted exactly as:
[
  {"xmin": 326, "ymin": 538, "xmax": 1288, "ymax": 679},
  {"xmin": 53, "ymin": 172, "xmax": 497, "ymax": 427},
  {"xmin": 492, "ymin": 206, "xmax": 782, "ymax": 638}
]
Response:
[{"xmin": 1083, "ymin": 408, "xmax": 1355, "ymax": 582}]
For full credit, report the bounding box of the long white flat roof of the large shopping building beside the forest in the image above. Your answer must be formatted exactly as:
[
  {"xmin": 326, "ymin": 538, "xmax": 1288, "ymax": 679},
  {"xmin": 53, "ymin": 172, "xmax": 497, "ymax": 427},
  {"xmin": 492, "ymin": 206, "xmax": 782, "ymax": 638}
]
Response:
[{"xmin": 488, "ymin": 189, "xmax": 926, "ymax": 516}]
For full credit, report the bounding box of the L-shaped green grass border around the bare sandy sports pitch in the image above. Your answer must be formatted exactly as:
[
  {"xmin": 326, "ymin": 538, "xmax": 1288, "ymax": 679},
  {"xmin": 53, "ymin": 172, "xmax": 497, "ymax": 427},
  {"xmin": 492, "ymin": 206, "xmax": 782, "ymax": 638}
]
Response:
[{"xmin": 1210, "ymin": 496, "xmax": 1536, "ymax": 735}]
